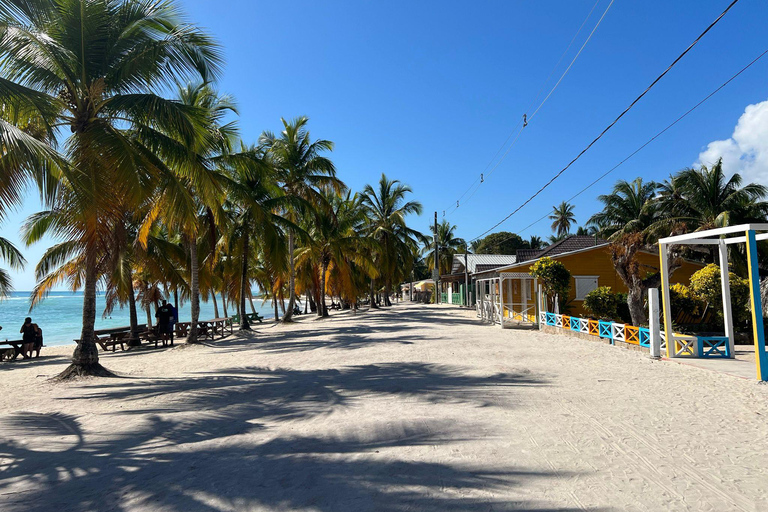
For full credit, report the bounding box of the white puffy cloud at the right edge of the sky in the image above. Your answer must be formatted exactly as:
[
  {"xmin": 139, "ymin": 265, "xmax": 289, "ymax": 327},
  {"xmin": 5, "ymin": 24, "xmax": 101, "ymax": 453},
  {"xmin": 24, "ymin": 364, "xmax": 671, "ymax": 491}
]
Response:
[{"xmin": 695, "ymin": 100, "xmax": 768, "ymax": 185}]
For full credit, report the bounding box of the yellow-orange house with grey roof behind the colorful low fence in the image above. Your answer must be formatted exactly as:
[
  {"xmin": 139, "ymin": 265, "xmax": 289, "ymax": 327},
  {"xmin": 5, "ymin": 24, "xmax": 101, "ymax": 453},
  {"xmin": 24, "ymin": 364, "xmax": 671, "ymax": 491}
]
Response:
[{"xmin": 475, "ymin": 236, "xmax": 704, "ymax": 322}]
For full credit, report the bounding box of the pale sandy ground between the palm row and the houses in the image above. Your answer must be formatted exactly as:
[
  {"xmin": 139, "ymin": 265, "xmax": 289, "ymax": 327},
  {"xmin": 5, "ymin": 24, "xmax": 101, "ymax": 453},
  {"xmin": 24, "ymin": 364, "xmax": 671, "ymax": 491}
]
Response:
[{"xmin": 0, "ymin": 305, "xmax": 768, "ymax": 512}]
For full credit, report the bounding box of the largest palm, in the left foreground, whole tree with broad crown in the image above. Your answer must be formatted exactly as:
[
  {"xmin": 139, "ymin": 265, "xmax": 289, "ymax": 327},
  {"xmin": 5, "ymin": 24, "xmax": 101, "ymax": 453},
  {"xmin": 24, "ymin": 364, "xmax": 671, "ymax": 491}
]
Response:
[{"xmin": 6, "ymin": 0, "xmax": 221, "ymax": 378}]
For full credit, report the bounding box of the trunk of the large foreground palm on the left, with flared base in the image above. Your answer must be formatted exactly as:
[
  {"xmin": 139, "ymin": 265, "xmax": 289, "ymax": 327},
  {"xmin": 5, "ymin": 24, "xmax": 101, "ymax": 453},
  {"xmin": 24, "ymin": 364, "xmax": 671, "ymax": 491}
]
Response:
[{"xmin": 56, "ymin": 249, "xmax": 114, "ymax": 380}]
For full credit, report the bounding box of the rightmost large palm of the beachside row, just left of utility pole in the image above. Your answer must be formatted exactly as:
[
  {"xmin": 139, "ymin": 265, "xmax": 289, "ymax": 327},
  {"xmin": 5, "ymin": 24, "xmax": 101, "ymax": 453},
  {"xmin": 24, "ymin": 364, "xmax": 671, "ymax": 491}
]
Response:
[{"xmin": 362, "ymin": 173, "xmax": 423, "ymax": 308}]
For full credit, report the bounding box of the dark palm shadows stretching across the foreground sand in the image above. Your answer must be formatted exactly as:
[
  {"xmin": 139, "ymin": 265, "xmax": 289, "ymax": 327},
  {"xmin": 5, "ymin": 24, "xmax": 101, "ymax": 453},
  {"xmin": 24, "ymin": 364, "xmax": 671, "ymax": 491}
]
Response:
[{"xmin": 0, "ymin": 363, "xmax": 592, "ymax": 512}]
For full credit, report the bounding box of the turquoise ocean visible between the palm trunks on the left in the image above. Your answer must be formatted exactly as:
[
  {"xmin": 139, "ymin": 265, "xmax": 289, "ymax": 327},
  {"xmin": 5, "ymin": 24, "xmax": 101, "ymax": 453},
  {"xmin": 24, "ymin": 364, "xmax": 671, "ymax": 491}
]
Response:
[{"xmin": 0, "ymin": 292, "xmax": 282, "ymax": 346}]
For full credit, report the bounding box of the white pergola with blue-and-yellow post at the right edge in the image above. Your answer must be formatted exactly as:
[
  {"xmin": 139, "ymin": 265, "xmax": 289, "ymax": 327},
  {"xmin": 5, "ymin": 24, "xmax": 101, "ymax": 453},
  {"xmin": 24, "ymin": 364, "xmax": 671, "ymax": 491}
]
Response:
[{"xmin": 659, "ymin": 224, "xmax": 768, "ymax": 380}]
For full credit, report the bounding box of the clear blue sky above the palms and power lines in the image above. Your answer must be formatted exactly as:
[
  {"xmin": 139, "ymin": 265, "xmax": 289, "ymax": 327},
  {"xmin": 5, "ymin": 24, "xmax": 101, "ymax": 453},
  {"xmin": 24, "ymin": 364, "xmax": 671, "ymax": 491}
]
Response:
[{"xmin": 2, "ymin": 0, "xmax": 768, "ymax": 290}]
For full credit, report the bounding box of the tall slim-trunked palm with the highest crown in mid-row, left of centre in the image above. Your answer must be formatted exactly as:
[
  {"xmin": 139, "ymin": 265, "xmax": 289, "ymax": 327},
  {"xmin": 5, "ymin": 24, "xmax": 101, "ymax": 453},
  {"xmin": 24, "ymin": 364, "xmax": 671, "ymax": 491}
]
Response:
[{"xmin": 261, "ymin": 117, "xmax": 343, "ymax": 322}]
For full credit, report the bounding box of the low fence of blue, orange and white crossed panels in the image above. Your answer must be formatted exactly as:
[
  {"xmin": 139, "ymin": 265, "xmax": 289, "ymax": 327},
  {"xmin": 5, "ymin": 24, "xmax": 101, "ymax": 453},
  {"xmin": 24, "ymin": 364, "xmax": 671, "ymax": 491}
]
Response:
[{"xmin": 539, "ymin": 311, "xmax": 672, "ymax": 357}]
